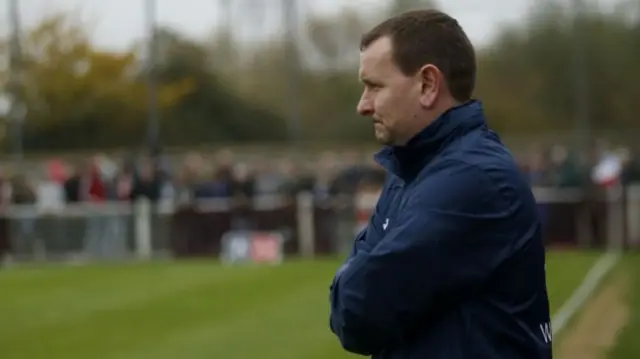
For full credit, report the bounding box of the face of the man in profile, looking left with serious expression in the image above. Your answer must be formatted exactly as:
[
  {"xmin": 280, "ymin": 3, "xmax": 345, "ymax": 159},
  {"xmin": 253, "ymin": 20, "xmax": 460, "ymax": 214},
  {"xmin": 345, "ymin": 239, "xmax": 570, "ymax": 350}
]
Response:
[{"xmin": 358, "ymin": 37, "xmax": 423, "ymax": 145}]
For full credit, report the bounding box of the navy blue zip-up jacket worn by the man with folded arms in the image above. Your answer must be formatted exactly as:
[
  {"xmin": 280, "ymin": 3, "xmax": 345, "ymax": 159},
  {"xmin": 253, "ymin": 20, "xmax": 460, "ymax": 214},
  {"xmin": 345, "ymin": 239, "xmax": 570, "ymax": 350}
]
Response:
[{"xmin": 330, "ymin": 101, "xmax": 551, "ymax": 359}]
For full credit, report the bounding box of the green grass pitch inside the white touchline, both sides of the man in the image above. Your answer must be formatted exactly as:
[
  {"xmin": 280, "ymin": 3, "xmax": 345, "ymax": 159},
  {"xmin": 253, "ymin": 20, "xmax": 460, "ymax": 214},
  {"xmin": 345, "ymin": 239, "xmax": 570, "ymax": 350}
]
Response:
[{"xmin": 0, "ymin": 252, "xmax": 598, "ymax": 359}]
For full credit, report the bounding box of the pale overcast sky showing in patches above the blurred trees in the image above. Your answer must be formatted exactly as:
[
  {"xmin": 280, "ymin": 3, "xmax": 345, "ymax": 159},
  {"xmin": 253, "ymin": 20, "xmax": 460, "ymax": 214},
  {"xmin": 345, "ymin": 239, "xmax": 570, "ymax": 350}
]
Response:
[{"xmin": 0, "ymin": 0, "xmax": 615, "ymax": 49}]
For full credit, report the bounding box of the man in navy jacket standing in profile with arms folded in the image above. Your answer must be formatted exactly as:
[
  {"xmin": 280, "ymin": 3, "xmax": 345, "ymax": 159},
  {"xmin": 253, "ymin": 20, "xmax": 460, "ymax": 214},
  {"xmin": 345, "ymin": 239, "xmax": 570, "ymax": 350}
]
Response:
[{"xmin": 330, "ymin": 10, "xmax": 551, "ymax": 359}]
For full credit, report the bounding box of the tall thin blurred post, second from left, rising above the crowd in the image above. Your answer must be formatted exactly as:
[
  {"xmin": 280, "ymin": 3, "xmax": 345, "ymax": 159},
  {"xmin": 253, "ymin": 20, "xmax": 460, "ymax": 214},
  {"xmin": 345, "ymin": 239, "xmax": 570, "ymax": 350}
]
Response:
[{"xmin": 145, "ymin": 0, "xmax": 160, "ymax": 151}]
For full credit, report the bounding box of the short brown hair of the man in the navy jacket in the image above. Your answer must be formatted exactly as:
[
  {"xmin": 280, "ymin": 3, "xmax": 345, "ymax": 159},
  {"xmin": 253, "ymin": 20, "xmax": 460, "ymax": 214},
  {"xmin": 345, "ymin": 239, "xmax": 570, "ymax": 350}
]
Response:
[{"xmin": 360, "ymin": 10, "xmax": 476, "ymax": 102}]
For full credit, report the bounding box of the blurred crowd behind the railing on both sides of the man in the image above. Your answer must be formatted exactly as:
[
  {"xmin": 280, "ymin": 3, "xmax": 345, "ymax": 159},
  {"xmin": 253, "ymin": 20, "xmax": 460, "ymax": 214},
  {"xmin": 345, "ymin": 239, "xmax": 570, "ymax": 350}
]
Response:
[{"xmin": 0, "ymin": 141, "xmax": 640, "ymax": 211}]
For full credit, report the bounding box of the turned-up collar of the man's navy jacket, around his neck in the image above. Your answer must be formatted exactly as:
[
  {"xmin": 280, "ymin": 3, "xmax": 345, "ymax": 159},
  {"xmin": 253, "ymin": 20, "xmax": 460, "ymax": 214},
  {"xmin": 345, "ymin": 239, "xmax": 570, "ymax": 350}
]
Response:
[{"xmin": 375, "ymin": 100, "xmax": 486, "ymax": 182}]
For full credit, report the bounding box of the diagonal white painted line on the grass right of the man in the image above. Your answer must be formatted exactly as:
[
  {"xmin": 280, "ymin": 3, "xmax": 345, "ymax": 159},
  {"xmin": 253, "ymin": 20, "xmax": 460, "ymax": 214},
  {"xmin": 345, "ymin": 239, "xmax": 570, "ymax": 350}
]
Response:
[{"xmin": 551, "ymin": 251, "xmax": 620, "ymax": 335}]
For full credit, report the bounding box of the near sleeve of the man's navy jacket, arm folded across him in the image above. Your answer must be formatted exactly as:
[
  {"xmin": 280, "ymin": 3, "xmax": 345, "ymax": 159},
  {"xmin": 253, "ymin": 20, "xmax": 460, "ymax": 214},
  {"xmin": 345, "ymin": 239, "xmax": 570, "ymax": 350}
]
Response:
[{"xmin": 331, "ymin": 162, "xmax": 517, "ymax": 355}]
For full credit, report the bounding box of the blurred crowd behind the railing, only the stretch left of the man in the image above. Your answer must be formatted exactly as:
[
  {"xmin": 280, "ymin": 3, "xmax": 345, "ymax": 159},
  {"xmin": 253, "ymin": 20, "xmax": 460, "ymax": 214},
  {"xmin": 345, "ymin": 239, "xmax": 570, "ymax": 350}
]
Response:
[{"xmin": 0, "ymin": 150, "xmax": 385, "ymax": 211}]
